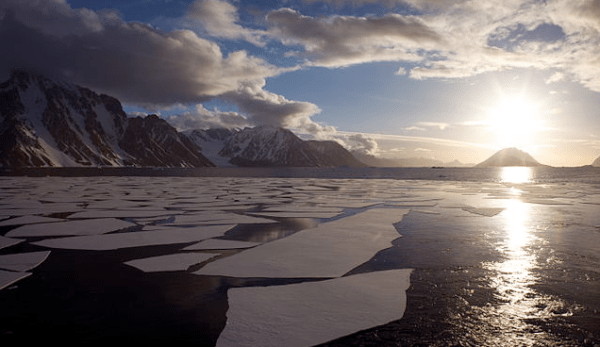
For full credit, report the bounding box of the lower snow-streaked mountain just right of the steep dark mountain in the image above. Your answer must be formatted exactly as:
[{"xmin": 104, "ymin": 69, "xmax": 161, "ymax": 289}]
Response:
[{"xmin": 185, "ymin": 126, "xmax": 365, "ymax": 167}]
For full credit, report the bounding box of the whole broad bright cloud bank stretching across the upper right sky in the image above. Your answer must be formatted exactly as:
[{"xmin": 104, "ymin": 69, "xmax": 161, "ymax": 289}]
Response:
[{"xmin": 255, "ymin": 0, "xmax": 600, "ymax": 91}]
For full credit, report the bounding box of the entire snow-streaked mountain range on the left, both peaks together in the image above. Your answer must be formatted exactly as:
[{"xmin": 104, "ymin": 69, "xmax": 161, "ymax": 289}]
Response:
[{"xmin": 0, "ymin": 71, "xmax": 365, "ymax": 167}]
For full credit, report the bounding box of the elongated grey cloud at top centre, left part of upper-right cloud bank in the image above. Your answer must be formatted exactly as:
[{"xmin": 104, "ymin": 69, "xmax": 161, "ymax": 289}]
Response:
[{"xmin": 267, "ymin": 8, "xmax": 443, "ymax": 67}]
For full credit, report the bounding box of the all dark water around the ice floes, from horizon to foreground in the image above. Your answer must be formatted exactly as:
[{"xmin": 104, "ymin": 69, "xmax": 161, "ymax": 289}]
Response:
[{"xmin": 0, "ymin": 167, "xmax": 600, "ymax": 347}]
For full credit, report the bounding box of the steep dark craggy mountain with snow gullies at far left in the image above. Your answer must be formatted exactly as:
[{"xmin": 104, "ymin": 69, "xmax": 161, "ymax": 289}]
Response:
[{"xmin": 0, "ymin": 71, "xmax": 213, "ymax": 167}]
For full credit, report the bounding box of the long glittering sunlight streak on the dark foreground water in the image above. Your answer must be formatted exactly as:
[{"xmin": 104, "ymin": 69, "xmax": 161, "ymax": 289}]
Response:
[{"xmin": 480, "ymin": 198, "xmax": 568, "ymax": 346}]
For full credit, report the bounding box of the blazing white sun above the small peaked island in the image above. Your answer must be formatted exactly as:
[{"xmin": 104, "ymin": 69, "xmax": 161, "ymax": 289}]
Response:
[{"xmin": 486, "ymin": 94, "xmax": 545, "ymax": 148}]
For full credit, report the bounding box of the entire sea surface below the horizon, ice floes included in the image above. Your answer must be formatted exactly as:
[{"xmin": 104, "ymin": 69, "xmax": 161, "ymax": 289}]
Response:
[{"xmin": 0, "ymin": 168, "xmax": 600, "ymax": 346}]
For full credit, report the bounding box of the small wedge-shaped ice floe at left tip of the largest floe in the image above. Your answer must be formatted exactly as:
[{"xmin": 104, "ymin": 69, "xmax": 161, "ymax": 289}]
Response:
[{"xmin": 125, "ymin": 253, "xmax": 219, "ymax": 272}]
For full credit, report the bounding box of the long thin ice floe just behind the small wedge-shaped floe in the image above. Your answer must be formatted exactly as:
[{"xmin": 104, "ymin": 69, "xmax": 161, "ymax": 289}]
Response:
[{"xmin": 33, "ymin": 225, "xmax": 234, "ymax": 251}]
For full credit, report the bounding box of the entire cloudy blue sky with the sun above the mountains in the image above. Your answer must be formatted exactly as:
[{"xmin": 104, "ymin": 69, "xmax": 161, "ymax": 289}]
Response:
[{"xmin": 0, "ymin": 0, "xmax": 600, "ymax": 166}]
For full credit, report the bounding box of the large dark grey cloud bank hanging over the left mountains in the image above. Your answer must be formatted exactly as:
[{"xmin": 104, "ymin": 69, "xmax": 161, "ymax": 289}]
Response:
[{"xmin": 0, "ymin": 0, "xmax": 330, "ymax": 135}]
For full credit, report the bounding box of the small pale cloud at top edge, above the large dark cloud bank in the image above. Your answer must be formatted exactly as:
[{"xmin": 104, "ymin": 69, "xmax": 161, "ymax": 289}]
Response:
[{"xmin": 187, "ymin": 0, "xmax": 265, "ymax": 46}]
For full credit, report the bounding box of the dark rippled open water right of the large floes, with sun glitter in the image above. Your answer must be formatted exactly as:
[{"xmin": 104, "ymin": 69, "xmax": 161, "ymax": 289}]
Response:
[{"xmin": 323, "ymin": 211, "xmax": 600, "ymax": 347}]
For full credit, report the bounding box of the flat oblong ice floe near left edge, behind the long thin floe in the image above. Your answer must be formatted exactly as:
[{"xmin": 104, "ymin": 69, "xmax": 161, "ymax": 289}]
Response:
[{"xmin": 6, "ymin": 218, "xmax": 135, "ymax": 237}]
